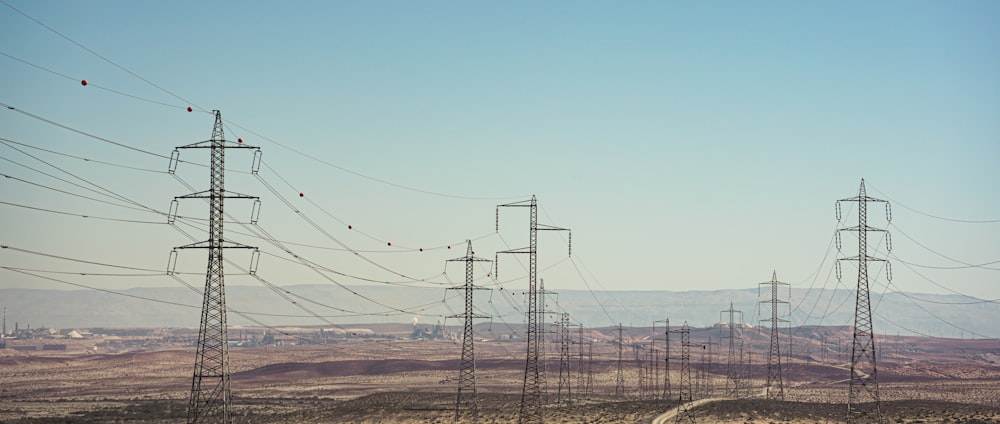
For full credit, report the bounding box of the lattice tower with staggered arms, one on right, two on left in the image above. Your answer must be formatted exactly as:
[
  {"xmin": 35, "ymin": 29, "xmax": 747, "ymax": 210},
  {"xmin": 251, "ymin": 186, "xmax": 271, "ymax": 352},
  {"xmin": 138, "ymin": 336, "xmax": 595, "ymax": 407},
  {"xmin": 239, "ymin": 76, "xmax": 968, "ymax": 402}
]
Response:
[{"xmin": 496, "ymin": 196, "xmax": 573, "ymax": 423}]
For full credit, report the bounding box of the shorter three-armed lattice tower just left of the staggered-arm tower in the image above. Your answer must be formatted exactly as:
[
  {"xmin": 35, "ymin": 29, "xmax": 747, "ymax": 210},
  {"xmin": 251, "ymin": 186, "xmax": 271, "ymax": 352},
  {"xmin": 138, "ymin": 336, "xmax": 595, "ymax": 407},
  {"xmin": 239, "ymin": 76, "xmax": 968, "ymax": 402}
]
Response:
[{"xmin": 448, "ymin": 240, "xmax": 489, "ymax": 421}]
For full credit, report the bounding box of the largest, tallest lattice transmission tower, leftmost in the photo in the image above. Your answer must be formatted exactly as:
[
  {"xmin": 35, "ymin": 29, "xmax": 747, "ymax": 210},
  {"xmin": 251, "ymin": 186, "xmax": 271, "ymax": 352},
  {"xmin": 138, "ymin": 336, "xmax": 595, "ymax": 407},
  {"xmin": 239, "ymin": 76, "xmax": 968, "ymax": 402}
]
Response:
[{"xmin": 168, "ymin": 110, "xmax": 259, "ymax": 423}]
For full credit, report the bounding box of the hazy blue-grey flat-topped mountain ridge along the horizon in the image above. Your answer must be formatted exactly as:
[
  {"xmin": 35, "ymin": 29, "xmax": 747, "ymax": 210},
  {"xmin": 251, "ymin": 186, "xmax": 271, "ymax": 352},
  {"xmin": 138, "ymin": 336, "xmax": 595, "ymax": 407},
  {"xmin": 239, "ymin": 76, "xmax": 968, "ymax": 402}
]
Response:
[{"xmin": 0, "ymin": 285, "xmax": 1000, "ymax": 338}]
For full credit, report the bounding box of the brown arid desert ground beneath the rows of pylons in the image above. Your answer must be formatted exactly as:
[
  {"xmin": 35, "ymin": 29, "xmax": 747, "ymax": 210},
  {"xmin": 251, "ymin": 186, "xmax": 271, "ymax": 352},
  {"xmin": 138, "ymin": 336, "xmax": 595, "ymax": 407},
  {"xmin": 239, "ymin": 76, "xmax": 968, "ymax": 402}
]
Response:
[{"xmin": 0, "ymin": 324, "xmax": 1000, "ymax": 423}]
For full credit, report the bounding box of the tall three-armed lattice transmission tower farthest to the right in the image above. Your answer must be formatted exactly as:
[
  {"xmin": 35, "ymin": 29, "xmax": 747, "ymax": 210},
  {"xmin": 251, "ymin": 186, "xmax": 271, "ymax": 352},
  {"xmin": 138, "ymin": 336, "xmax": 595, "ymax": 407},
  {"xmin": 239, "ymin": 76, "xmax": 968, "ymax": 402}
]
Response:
[{"xmin": 837, "ymin": 179, "xmax": 892, "ymax": 423}]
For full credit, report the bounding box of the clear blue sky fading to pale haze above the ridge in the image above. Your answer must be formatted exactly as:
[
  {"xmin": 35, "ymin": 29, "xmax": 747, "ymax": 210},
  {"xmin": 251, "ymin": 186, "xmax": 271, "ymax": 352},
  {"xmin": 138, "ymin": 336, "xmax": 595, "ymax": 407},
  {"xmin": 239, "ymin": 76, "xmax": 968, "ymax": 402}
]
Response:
[{"xmin": 0, "ymin": 0, "xmax": 1000, "ymax": 322}]
